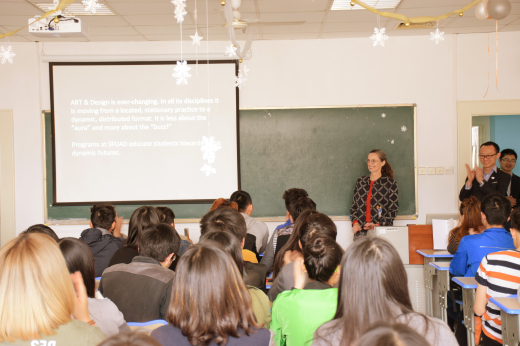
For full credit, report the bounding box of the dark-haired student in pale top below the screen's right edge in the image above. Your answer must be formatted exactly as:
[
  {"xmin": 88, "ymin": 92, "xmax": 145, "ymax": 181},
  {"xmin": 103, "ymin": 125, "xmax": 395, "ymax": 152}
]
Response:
[{"xmin": 229, "ymin": 191, "xmax": 269, "ymax": 253}]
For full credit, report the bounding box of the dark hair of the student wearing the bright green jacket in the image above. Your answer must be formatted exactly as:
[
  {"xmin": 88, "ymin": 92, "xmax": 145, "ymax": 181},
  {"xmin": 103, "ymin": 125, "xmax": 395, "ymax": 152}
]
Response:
[{"xmin": 303, "ymin": 235, "xmax": 343, "ymax": 283}]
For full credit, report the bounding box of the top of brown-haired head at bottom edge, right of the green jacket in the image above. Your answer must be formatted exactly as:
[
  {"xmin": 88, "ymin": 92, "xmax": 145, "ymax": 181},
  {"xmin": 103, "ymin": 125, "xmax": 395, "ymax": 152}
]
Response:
[{"xmin": 354, "ymin": 321, "xmax": 430, "ymax": 346}]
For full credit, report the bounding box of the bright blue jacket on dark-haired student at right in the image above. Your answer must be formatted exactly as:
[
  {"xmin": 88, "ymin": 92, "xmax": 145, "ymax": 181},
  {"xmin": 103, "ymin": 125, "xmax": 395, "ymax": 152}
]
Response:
[{"xmin": 450, "ymin": 228, "xmax": 515, "ymax": 277}]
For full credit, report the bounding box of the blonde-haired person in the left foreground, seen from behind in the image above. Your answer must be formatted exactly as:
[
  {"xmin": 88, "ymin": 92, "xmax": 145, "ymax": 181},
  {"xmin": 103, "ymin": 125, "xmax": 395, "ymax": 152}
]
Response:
[{"xmin": 0, "ymin": 233, "xmax": 105, "ymax": 346}]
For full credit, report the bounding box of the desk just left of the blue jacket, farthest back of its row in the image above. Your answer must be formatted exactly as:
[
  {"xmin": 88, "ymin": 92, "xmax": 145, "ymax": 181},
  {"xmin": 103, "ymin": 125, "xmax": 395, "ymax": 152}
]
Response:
[{"xmin": 417, "ymin": 249, "xmax": 453, "ymax": 318}]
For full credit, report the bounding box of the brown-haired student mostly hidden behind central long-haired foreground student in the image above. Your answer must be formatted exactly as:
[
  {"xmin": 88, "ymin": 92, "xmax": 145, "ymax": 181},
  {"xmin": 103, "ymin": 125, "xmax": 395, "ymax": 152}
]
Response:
[{"xmin": 200, "ymin": 207, "xmax": 267, "ymax": 290}]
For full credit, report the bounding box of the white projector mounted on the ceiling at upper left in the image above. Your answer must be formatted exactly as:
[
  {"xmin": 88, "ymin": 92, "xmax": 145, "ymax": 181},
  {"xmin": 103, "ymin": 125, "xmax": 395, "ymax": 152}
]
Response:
[{"xmin": 29, "ymin": 15, "xmax": 89, "ymax": 37}]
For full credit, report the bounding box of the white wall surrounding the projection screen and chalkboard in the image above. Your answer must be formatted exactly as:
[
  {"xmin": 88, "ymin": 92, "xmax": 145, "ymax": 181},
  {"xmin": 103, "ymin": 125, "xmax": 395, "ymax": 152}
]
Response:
[{"xmin": 4, "ymin": 32, "xmax": 520, "ymax": 249}]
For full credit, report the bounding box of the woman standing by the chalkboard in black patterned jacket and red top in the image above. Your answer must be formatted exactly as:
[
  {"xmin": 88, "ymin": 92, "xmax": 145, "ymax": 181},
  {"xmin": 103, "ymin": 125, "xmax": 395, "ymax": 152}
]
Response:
[{"xmin": 350, "ymin": 149, "xmax": 399, "ymax": 237}]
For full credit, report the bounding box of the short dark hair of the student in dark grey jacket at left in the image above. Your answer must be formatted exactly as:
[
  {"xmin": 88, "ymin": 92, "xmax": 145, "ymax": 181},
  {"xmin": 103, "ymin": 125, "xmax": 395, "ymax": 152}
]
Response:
[{"xmin": 139, "ymin": 223, "xmax": 181, "ymax": 262}]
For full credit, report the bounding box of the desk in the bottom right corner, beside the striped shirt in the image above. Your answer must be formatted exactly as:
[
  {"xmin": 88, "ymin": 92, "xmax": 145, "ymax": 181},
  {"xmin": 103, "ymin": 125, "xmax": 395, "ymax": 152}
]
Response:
[{"xmin": 489, "ymin": 295, "xmax": 520, "ymax": 346}]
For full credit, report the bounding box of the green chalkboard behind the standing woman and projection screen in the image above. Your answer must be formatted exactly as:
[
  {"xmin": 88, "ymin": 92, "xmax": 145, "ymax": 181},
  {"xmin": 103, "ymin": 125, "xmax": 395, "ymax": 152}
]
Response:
[{"xmin": 44, "ymin": 105, "xmax": 417, "ymax": 220}]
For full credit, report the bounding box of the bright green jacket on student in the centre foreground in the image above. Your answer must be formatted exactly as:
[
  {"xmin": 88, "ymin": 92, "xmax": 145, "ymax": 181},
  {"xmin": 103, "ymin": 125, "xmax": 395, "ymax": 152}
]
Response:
[{"xmin": 270, "ymin": 288, "xmax": 338, "ymax": 346}]
